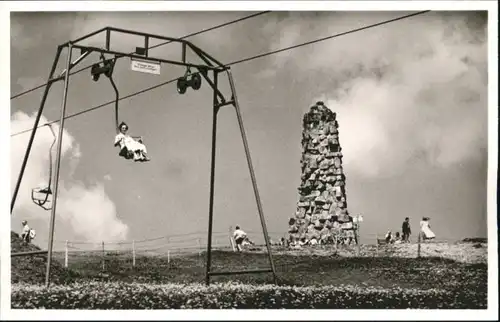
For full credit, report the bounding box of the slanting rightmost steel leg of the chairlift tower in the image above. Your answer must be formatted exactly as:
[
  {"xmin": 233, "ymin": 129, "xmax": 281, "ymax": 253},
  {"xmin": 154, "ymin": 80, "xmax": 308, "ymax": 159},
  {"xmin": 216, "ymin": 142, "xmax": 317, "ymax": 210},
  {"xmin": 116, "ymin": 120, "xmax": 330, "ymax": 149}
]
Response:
[{"xmin": 226, "ymin": 68, "xmax": 277, "ymax": 284}]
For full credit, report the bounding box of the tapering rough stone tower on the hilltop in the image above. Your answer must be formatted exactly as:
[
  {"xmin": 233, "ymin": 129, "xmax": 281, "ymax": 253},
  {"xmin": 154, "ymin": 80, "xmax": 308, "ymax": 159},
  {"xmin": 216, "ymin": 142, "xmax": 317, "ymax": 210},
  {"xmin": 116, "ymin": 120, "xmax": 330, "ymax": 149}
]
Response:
[{"xmin": 288, "ymin": 102, "xmax": 355, "ymax": 243}]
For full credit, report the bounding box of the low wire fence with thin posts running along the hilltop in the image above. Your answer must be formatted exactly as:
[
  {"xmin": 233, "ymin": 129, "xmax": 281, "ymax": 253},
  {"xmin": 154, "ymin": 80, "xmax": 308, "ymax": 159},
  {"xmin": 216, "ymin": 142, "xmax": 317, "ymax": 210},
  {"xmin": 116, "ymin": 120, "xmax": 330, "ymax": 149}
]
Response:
[{"xmin": 20, "ymin": 226, "xmax": 480, "ymax": 271}]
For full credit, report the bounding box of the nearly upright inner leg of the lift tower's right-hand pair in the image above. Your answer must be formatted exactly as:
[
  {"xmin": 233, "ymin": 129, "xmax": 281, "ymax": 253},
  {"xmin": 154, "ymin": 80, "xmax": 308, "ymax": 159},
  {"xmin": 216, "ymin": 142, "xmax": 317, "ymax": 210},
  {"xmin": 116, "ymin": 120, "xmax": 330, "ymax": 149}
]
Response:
[{"xmin": 205, "ymin": 70, "xmax": 219, "ymax": 285}]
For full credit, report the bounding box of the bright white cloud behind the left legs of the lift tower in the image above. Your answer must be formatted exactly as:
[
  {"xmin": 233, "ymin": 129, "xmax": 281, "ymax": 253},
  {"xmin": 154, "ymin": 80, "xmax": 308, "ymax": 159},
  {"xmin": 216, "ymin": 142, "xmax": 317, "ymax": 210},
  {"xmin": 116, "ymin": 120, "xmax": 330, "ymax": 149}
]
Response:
[{"xmin": 11, "ymin": 112, "xmax": 128, "ymax": 241}]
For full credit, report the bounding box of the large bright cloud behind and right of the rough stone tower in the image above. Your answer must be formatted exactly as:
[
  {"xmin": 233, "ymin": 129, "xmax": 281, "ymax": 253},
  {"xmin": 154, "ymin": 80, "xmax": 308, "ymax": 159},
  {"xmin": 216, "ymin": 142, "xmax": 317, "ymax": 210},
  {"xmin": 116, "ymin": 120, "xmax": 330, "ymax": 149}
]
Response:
[{"xmin": 282, "ymin": 13, "xmax": 487, "ymax": 176}]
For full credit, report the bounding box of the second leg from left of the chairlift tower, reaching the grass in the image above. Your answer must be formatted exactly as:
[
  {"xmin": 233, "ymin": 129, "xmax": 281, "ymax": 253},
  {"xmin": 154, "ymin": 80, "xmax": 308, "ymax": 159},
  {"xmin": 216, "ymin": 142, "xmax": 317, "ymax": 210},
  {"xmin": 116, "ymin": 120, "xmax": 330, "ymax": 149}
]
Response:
[{"xmin": 45, "ymin": 43, "xmax": 73, "ymax": 287}]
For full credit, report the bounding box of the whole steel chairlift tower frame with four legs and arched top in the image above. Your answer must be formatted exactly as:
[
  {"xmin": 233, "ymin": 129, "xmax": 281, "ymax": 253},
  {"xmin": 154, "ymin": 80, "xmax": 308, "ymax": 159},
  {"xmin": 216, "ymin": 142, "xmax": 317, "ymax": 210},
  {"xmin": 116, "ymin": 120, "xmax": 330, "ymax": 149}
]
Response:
[{"xmin": 10, "ymin": 27, "xmax": 277, "ymax": 287}]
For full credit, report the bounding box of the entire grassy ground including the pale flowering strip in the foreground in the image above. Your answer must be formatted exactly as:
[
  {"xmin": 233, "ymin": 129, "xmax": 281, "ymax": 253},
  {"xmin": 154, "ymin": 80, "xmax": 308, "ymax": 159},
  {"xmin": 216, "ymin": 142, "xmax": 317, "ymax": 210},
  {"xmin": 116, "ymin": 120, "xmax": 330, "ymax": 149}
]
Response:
[{"xmin": 11, "ymin": 234, "xmax": 487, "ymax": 309}]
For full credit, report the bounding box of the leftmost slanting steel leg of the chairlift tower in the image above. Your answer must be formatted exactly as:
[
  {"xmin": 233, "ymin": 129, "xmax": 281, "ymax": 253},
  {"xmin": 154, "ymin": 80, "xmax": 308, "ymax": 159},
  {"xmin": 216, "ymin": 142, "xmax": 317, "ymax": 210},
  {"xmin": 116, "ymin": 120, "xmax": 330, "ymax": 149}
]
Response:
[{"xmin": 10, "ymin": 46, "xmax": 63, "ymax": 214}]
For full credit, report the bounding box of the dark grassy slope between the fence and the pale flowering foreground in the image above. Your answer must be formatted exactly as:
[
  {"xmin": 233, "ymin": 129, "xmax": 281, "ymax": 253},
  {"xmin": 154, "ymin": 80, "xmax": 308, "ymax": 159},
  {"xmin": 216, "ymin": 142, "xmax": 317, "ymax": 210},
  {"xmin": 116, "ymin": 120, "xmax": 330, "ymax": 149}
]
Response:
[{"xmin": 12, "ymin": 235, "xmax": 487, "ymax": 289}]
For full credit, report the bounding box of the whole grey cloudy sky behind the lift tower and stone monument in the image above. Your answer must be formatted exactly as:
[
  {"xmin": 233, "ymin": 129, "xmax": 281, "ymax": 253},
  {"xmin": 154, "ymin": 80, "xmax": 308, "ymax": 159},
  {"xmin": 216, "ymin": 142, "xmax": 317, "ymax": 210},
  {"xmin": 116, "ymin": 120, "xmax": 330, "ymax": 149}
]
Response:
[{"xmin": 10, "ymin": 12, "xmax": 488, "ymax": 247}]
